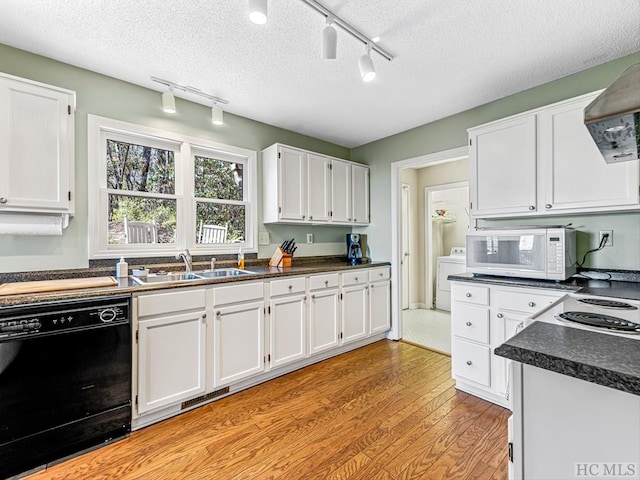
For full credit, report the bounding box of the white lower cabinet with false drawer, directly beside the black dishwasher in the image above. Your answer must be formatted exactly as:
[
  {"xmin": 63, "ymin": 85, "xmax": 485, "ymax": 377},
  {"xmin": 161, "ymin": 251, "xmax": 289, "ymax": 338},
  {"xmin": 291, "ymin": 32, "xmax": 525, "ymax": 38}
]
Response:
[{"xmin": 135, "ymin": 289, "xmax": 207, "ymax": 414}]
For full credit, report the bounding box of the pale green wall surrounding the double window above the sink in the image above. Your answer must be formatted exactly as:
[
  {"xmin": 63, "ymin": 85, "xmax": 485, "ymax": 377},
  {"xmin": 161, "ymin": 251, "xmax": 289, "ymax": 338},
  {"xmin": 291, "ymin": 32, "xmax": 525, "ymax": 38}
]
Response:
[{"xmin": 0, "ymin": 44, "xmax": 351, "ymax": 272}]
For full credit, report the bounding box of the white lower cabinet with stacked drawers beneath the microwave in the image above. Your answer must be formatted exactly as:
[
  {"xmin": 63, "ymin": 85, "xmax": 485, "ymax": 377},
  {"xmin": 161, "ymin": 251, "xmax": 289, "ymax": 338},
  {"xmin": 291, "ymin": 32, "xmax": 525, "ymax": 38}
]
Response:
[{"xmin": 451, "ymin": 282, "xmax": 563, "ymax": 407}]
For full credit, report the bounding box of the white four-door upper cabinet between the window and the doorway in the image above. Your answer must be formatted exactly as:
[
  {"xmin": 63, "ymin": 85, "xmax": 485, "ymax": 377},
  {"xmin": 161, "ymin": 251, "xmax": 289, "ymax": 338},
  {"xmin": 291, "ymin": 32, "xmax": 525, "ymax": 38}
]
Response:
[{"xmin": 262, "ymin": 144, "xmax": 369, "ymax": 225}]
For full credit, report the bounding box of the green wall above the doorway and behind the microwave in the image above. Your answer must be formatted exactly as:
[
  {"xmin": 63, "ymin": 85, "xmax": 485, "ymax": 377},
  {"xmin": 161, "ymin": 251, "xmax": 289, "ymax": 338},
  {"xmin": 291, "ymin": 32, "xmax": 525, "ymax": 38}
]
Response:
[{"xmin": 351, "ymin": 52, "xmax": 640, "ymax": 270}]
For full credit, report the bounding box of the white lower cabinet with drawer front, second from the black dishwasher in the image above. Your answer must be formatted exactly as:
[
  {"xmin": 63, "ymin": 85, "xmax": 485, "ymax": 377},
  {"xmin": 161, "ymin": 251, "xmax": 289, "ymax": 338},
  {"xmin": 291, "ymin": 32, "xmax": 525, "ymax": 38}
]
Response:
[{"xmin": 213, "ymin": 282, "xmax": 265, "ymax": 388}]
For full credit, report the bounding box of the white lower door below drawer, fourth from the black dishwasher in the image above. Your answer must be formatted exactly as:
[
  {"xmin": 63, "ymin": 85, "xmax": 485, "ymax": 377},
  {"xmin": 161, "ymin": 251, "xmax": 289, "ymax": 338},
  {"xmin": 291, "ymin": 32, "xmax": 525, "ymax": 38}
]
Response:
[{"xmin": 309, "ymin": 289, "xmax": 340, "ymax": 355}]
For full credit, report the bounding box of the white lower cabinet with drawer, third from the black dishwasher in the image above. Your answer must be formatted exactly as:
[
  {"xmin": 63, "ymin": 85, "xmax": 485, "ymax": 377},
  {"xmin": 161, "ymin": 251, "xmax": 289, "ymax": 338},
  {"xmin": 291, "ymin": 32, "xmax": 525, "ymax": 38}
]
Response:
[{"xmin": 267, "ymin": 277, "xmax": 307, "ymax": 368}]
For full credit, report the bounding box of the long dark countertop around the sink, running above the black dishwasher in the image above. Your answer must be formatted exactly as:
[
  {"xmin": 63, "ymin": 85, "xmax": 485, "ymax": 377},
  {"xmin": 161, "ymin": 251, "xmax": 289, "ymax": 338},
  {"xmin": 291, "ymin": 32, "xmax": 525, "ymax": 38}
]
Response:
[{"xmin": 0, "ymin": 258, "xmax": 391, "ymax": 312}]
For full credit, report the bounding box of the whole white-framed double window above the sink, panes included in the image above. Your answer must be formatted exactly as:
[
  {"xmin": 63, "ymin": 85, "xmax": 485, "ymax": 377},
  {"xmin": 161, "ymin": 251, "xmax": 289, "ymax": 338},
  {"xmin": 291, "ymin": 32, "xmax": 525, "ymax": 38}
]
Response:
[{"xmin": 89, "ymin": 115, "xmax": 257, "ymax": 258}]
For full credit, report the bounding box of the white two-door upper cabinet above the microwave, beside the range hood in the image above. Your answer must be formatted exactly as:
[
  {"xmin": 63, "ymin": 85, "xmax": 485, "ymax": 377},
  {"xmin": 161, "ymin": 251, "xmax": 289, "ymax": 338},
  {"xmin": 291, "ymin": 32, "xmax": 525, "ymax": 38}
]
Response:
[{"xmin": 469, "ymin": 92, "xmax": 640, "ymax": 218}]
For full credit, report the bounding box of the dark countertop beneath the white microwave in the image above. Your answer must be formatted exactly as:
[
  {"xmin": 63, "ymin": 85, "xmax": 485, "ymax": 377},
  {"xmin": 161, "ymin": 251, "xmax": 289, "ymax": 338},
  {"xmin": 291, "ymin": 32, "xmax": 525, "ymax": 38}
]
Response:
[{"xmin": 448, "ymin": 272, "xmax": 640, "ymax": 300}]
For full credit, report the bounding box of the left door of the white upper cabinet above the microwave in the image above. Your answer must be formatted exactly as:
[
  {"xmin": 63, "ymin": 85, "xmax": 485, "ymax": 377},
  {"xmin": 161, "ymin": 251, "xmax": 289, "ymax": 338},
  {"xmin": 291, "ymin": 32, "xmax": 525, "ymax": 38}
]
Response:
[{"xmin": 469, "ymin": 115, "xmax": 536, "ymax": 217}]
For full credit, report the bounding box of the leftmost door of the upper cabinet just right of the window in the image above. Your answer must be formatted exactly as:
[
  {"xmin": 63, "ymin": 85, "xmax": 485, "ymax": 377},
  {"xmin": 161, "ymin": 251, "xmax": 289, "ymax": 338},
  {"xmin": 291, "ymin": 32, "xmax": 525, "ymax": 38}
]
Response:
[{"xmin": 278, "ymin": 147, "xmax": 307, "ymax": 220}]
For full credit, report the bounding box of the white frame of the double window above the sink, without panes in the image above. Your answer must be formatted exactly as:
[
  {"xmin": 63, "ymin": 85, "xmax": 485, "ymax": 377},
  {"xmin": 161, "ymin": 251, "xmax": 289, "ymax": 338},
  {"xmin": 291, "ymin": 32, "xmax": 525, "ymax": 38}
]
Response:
[{"xmin": 87, "ymin": 114, "xmax": 258, "ymax": 259}]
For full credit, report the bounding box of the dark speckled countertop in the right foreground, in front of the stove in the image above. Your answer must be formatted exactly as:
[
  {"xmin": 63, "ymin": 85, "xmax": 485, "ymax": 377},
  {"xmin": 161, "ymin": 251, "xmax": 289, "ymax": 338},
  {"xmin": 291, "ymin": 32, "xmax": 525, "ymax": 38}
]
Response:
[{"xmin": 495, "ymin": 322, "xmax": 640, "ymax": 395}]
